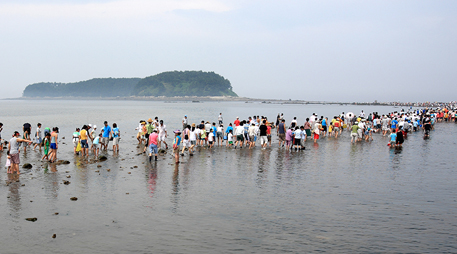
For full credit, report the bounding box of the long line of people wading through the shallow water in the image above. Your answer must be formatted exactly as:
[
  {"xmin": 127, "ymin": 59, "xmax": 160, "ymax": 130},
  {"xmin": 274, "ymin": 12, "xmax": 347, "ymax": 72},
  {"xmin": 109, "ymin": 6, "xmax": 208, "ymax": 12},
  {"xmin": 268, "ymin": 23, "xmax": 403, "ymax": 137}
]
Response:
[{"xmin": 0, "ymin": 103, "xmax": 457, "ymax": 174}]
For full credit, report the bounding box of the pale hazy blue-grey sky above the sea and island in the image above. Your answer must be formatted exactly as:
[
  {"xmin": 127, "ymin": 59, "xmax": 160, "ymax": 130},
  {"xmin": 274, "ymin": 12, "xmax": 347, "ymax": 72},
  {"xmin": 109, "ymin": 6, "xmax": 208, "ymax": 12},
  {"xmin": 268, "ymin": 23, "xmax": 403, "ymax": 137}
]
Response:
[{"xmin": 0, "ymin": 0, "xmax": 457, "ymax": 102}]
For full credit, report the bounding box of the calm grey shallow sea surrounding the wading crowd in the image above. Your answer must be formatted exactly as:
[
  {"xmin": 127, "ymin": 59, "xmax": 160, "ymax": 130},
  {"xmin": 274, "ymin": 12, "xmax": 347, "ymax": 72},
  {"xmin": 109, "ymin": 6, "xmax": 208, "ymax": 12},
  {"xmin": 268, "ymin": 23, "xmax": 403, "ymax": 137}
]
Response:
[{"xmin": 0, "ymin": 100, "xmax": 457, "ymax": 253}]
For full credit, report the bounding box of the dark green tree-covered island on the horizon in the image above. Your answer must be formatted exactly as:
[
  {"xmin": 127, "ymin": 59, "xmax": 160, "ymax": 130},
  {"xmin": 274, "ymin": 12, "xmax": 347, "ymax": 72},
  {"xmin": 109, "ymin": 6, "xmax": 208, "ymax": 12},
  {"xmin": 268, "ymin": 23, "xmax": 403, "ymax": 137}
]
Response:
[{"xmin": 23, "ymin": 71, "xmax": 238, "ymax": 97}]
